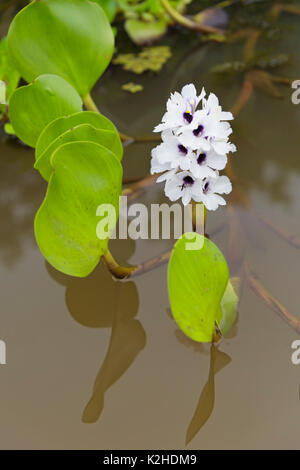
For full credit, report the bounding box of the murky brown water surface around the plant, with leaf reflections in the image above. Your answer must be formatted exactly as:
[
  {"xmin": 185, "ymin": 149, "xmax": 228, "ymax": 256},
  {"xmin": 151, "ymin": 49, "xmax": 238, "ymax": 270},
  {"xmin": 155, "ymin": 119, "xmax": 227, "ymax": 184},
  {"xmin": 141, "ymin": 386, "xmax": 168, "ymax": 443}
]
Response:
[{"xmin": 0, "ymin": 11, "xmax": 300, "ymax": 449}]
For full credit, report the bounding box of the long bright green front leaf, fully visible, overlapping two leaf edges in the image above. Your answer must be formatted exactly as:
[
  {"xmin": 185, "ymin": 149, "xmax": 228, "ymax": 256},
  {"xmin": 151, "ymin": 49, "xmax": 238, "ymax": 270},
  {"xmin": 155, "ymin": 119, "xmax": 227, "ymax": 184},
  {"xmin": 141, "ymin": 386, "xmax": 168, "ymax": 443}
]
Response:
[{"xmin": 35, "ymin": 142, "xmax": 122, "ymax": 277}]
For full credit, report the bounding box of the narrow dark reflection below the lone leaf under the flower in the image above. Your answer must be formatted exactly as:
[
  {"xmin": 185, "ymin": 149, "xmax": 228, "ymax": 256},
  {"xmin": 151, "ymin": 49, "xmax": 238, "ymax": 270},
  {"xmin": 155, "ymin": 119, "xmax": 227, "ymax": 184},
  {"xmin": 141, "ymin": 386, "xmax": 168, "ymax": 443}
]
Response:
[{"xmin": 185, "ymin": 344, "xmax": 231, "ymax": 445}]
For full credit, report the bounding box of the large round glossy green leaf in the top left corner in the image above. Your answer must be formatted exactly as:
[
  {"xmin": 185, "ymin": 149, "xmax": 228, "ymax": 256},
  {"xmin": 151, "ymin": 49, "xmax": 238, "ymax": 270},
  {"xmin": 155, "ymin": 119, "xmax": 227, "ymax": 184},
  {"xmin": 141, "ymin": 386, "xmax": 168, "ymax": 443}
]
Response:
[{"xmin": 8, "ymin": 0, "xmax": 114, "ymax": 97}]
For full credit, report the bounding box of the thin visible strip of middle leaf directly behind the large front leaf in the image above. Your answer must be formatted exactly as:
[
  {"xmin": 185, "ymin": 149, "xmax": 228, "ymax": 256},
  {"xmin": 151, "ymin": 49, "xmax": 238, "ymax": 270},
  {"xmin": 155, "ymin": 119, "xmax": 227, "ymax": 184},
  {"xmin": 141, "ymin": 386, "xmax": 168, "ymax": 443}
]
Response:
[{"xmin": 34, "ymin": 124, "xmax": 123, "ymax": 181}]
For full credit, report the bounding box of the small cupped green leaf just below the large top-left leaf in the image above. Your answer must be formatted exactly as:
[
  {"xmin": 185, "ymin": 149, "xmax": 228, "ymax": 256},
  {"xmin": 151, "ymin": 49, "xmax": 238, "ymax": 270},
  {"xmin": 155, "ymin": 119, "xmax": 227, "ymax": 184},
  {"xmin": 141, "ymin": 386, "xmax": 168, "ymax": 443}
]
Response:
[{"xmin": 9, "ymin": 75, "xmax": 82, "ymax": 147}]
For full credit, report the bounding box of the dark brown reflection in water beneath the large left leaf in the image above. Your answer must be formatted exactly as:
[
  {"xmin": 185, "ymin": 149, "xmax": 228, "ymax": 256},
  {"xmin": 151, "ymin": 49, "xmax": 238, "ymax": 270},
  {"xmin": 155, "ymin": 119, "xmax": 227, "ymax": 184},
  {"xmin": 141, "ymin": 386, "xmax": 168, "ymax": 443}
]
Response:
[{"xmin": 47, "ymin": 264, "xmax": 146, "ymax": 423}]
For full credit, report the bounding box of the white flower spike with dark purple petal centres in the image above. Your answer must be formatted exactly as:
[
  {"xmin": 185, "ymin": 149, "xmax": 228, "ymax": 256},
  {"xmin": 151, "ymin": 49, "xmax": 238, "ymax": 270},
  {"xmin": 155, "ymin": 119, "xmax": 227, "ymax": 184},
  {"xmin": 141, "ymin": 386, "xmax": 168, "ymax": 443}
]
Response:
[{"xmin": 151, "ymin": 84, "xmax": 236, "ymax": 210}]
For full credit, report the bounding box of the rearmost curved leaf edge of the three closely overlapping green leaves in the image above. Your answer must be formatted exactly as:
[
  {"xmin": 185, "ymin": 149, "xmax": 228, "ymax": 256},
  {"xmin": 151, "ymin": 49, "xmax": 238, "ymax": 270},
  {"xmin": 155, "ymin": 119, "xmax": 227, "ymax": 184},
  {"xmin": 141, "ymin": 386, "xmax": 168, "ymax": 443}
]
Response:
[{"xmin": 35, "ymin": 111, "xmax": 123, "ymax": 161}]
